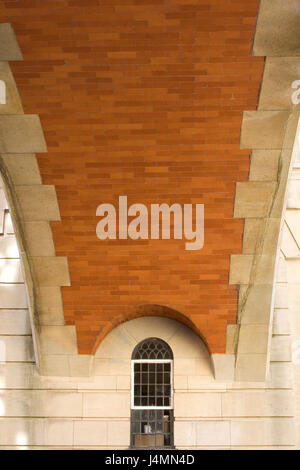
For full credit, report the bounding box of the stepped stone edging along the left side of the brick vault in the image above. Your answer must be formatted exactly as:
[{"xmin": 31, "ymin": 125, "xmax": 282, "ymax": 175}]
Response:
[{"xmin": 0, "ymin": 23, "xmax": 92, "ymax": 376}]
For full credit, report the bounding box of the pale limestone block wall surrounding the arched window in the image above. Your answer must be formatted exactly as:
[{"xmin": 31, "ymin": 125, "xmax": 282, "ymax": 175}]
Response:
[{"xmin": 0, "ymin": 177, "xmax": 295, "ymax": 449}]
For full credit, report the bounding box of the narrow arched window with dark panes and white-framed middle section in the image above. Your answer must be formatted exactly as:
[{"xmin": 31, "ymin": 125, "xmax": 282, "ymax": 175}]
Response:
[{"xmin": 131, "ymin": 338, "xmax": 173, "ymax": 449}]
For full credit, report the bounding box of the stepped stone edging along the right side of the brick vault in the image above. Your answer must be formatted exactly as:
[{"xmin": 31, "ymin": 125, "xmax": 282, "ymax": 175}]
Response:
[{"xmin": 228, "ymin": 0, "xmax": 300, "ymax": 382}]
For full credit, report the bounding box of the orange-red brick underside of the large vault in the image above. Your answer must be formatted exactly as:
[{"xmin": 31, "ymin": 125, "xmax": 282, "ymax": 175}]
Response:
[{"xmin": 0, "ymin": 0, "xmax": 263, "ymax": 353}]
